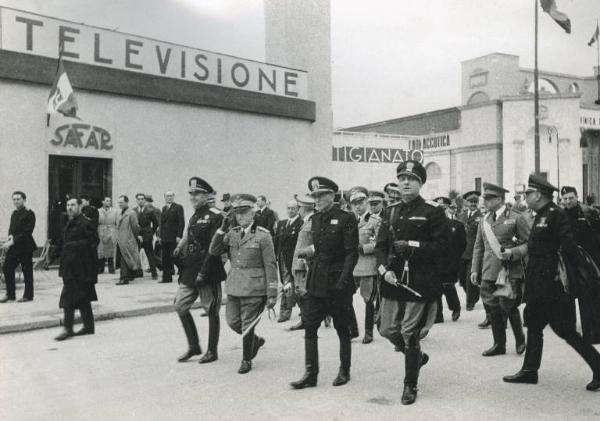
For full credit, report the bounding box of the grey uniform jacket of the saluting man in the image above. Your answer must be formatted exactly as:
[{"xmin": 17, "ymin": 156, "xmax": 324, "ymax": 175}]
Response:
[{"xmin": 209, "ymin": 223, "xmax": 278, "ymax": 297}]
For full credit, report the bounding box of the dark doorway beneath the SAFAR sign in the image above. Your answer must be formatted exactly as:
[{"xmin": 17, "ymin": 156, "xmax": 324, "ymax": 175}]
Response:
[{"xmin": 48, "ymin": 155, "xmax": 112, "ymax": 244}]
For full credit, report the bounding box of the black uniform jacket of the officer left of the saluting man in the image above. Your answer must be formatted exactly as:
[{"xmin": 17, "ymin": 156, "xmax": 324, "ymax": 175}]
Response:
[{"xmin": 180, "ymin": 206, "xmax": 226, "ymax": 286}]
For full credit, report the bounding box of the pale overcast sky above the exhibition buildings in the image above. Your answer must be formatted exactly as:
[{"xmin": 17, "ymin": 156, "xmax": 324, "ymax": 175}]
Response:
[{"xmin": 0, "ymin": 0, "xmax": 600, "ymax": 127}]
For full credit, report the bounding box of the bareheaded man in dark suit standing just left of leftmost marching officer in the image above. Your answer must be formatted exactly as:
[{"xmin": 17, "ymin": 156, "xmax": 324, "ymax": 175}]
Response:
[{"xmin": 158, "ymin": 191, "xmax": 185, "ymax": 283}]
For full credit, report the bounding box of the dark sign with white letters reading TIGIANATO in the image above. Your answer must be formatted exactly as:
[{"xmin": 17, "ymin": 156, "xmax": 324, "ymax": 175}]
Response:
[{"xmin": 331, "ymin": 146, "xmax": 424, "ymax": 164}]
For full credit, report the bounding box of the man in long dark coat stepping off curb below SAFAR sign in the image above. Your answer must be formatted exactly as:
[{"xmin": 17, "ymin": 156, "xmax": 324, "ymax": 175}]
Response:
[{"xmin": 54, "ymin": 199, "xmax": 99, "ymax": 341}]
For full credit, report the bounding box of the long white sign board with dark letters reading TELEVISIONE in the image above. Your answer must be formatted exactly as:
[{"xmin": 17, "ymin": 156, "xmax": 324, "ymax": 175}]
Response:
[{"xmin": 0, "ymin": 8, "xmax": 308, "ymax": 99}]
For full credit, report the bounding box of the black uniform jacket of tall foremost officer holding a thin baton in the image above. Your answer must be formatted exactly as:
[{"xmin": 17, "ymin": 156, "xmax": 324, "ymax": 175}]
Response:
[{"xmin": 375, "ymin": 196, "xmax": 450, "ymax": 301}]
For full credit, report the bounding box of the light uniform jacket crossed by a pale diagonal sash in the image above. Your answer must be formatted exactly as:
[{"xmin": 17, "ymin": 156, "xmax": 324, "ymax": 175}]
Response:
[{"xmin": 471, "ymin": 208, "xmax": 530, "ymax": 281}]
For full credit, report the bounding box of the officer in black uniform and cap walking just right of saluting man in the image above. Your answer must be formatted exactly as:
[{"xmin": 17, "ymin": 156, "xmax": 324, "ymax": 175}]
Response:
[{"xmin": 291, "ymin": 177, "xmax": 358, "ymax": 389}]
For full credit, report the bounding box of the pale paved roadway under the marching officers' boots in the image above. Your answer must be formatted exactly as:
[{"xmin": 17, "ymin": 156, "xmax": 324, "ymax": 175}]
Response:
[{"xmin": 0, "ymin": 297, "xmax": 600, "ymax": 421}]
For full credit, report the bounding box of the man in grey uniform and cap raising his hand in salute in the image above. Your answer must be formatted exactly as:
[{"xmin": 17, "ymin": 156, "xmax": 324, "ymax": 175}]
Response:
[{"xmin": 209, "ymin": 194, "xmax": 278, "ymax": 374}]
